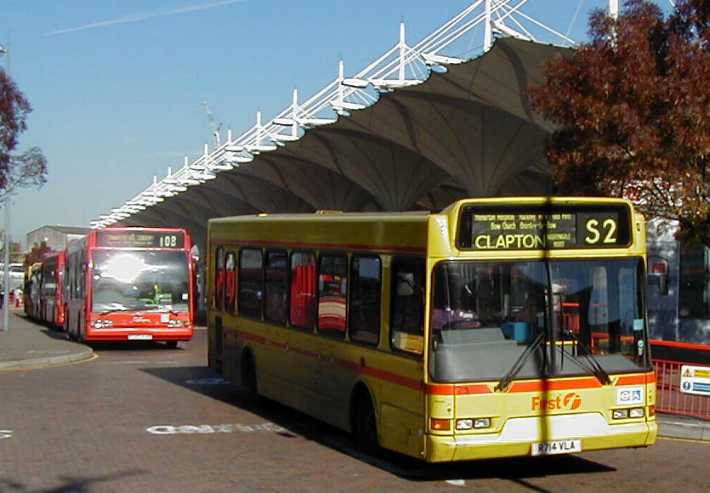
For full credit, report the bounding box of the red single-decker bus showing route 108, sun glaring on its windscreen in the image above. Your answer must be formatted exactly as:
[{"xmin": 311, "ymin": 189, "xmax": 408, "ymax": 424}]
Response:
[{"xmin": 64, "ymin": 227, "xmax": 194, "ymax": 347}]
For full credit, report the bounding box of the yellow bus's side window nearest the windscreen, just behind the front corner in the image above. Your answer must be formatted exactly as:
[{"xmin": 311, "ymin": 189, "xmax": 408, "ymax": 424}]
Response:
[{"xmin": 390, "ymin": 257, "xmax": 424, "ymax": 354}]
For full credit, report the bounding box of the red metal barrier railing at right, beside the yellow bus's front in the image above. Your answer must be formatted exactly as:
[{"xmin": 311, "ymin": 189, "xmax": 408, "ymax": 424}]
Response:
[{"xmin": 653, "ymin": 359, "xmax": 710, "ymax": 419}]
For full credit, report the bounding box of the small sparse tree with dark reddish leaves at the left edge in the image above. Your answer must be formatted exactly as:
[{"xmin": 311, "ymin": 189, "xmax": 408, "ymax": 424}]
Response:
[{"xmin": 0, "ymin": 68, "xmax": 47, "ymax": 200}]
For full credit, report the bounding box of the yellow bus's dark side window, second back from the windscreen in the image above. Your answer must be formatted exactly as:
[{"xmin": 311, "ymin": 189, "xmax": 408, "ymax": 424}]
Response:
[{"xmin": 348, "ymin": 256, "xmax": 382, "ymax": 346}]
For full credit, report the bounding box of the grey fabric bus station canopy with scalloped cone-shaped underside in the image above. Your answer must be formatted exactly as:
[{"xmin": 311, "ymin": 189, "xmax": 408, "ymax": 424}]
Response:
[{"xmin": 123, "ymin": 38, "xmax": 566, "ymax": 248}]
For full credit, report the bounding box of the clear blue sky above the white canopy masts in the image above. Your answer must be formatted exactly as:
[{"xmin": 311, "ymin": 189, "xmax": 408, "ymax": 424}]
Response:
[{"xmin": 0, "ymin": 0, "xmax": 667, "ymax": 246}]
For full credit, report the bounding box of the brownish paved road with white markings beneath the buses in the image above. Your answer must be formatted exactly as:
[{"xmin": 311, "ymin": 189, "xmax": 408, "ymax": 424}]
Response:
[{"xmin": 0, "ymin": 320, "xmax": 710, "ymax": 493}]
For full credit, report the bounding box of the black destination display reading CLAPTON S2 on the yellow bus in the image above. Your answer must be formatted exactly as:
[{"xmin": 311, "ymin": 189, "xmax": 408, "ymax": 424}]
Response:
[{"xmin": 458, "ymin": 204, "xmax": 631, "ymax": 250}]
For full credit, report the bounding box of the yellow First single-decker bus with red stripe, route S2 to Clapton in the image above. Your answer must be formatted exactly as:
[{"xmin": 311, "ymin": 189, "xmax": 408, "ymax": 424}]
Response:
[{"xmin": 208, "ymin": 197, "xmax": 657, "ymax": 462}]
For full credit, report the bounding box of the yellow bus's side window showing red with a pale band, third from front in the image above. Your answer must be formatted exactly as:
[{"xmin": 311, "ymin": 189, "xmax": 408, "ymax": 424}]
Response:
[{"xmin": 318, "ymin": 254, "xmax": 348, "ymax": 339}]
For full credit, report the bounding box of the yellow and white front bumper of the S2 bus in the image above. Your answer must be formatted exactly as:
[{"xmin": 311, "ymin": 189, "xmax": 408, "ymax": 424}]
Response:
[{"xmin": 424, "ymin": 415, "xmax": 658, "ymax": 462}]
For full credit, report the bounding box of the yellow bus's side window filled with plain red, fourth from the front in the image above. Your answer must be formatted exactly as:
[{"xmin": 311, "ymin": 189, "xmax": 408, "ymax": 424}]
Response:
[{"xmin": 289, "ymin": 252, "xmax": 316, "ymax": 331}]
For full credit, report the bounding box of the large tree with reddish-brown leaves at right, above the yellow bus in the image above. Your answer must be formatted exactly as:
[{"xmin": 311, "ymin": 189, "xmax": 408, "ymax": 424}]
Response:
[{"xmin": 531, "ymin": 0, "xmax": 710, "ymax": 246}]
